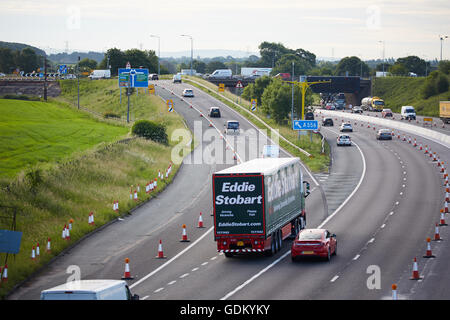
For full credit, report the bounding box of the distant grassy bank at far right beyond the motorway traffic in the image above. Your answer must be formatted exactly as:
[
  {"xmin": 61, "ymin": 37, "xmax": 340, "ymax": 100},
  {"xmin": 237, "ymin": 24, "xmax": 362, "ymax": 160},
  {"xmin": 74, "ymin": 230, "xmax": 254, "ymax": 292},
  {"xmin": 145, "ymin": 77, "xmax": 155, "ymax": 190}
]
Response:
[{"xmin": 373, "ymin": 77, "xmax": 450, "ymax": 117}]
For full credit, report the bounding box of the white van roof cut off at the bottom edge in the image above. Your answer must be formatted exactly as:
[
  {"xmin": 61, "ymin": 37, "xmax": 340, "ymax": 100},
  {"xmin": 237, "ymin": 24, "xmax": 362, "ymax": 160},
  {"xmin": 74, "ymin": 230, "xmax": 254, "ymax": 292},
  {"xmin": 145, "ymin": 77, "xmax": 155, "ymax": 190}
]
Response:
[{"xmin": 41, "ymin": 280, "xmax": 139, "ymax": 300}]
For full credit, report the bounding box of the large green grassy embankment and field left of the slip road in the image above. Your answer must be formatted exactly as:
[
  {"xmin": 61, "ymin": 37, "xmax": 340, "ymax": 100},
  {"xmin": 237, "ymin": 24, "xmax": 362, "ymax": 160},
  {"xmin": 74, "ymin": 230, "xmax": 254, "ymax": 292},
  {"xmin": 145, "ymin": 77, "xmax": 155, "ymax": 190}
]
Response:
[{"xmin": 0, "ymin": 80, "xmax": 190, "ymax": 298}]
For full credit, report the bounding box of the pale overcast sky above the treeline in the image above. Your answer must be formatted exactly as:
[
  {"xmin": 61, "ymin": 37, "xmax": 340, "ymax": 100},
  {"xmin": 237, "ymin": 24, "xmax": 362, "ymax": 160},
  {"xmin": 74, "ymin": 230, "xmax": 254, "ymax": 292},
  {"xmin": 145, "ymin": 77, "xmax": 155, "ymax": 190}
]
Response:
[{"xmin": 0, "ymin": 0, "xmax": 450, "ymax": 60}]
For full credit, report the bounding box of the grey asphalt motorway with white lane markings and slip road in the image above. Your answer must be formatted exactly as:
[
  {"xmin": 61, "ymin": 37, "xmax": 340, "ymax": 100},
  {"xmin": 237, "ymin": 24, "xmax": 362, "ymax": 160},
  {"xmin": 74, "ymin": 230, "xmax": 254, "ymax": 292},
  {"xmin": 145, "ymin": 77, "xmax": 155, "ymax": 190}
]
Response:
[{"xmin": 8, "ymin": 81, "xmax": 450, "ymax": 300}]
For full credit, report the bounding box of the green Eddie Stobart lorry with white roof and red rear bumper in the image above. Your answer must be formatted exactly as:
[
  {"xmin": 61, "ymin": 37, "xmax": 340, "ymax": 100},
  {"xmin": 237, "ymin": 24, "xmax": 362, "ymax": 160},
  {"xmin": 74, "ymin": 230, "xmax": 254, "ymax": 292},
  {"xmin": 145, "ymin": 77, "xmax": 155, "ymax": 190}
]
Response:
[{"xmin": 212, "ymin": 158, "xmax": 310, "ymax": 257}]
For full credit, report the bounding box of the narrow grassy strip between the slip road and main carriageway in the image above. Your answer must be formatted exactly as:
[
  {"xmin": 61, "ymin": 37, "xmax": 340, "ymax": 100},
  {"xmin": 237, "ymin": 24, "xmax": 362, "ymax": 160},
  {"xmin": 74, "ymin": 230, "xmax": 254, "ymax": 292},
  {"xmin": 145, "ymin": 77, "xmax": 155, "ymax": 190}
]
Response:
[{"xmin": 185, "ymin": 76, "xmax": 330, "ymax": 172}]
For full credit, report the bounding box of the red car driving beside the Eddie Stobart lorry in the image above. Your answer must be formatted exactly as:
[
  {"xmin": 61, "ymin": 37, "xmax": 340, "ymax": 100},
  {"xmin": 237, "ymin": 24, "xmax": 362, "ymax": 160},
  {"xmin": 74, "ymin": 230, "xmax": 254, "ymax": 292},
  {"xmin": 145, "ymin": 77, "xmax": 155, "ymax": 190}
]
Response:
[{"xmin": 291, "ymin": 229, "xmax": 337, "ymax": 261}]
